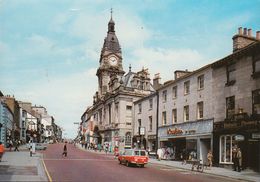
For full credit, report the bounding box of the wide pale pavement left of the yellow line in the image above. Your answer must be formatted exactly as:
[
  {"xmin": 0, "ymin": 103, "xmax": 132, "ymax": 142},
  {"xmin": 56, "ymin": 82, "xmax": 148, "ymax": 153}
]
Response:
[{"xmin": 0, "ymin": 146, "xmax": 48, "ymax": 181}]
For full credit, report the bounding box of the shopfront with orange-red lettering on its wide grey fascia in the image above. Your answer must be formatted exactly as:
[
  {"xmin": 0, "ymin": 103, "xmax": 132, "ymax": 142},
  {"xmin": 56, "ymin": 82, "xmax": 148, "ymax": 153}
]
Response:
[{"xmin": 158, "ymin": 120, "xmax": 213, "ymax": 163}]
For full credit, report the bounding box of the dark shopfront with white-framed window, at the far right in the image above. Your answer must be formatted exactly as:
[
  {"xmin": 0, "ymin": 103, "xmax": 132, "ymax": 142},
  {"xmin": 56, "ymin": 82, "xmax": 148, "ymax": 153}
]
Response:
[{"xmin": 214, "ymin": 121, "xmax": 260, "ymax": 171}]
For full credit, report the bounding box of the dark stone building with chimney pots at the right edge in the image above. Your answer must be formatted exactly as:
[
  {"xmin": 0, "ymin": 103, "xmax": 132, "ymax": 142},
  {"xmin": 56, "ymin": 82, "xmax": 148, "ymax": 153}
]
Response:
[{"xmin": 212, "ymin": 28, "xmax": 260, "ymax": 171}]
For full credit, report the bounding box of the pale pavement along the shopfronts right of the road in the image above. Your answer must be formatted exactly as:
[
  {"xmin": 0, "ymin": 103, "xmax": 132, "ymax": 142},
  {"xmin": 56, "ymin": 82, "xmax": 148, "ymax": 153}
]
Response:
[{"xmin": 77, "ymin": 145, "xmax": 260, "ymax": 182}]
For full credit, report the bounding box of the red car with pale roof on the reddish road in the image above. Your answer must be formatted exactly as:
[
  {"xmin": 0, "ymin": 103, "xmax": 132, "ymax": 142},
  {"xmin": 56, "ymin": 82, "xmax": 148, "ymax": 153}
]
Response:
[{"xmin": 118, "ymin": 149, "xmax": 148, "ymax": 167}]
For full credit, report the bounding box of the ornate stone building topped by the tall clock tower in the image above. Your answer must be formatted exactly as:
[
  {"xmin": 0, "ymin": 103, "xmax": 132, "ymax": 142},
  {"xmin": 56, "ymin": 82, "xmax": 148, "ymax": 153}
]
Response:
[{"xmin": 81, "ymin": 14, "xmax": 154, "ymax": 150}]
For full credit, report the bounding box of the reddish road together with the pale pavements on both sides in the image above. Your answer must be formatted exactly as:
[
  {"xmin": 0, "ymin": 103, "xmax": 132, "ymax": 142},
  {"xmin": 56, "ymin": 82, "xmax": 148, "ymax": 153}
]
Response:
[{"xmin": 0, "ymin": 143, "xmax": 260, "ymax": 182}]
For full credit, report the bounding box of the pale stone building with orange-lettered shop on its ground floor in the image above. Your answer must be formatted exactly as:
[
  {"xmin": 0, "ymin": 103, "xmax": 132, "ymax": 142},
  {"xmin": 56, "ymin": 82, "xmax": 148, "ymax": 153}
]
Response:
[{"xmin": 157, "ymin": 65, "xmax": 213, "ymax": 162}]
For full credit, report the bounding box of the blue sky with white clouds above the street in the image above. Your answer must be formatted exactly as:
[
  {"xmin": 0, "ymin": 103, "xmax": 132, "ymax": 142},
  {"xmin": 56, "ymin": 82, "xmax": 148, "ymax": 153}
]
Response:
[{"xmin": 0, "ymin": 0, "xmax": 260, "ymax": 138}]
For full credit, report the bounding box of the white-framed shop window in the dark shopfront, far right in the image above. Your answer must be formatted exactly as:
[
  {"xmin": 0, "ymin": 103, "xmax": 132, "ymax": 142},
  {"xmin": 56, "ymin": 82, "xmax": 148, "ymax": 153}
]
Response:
[{"xmin": 219, "ymin": 135, "xmax": 235, "ymax": 164}]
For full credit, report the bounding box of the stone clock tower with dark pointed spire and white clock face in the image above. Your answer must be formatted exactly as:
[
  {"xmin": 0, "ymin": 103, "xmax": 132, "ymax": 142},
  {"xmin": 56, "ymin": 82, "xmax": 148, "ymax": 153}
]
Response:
[{"xmin": 96, "ymin": 9, "xmax": 125, "ymax": 97}]
